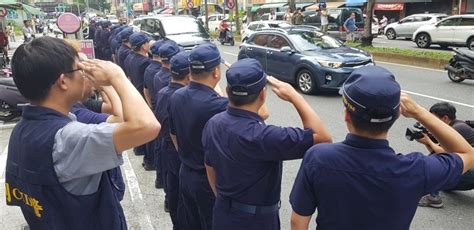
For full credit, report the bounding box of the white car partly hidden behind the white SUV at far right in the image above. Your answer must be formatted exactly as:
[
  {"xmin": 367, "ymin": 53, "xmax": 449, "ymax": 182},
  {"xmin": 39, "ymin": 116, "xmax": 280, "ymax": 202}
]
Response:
[{"xmin": 384, "ymin": 14, "xmax": 448, "ymax": 40}]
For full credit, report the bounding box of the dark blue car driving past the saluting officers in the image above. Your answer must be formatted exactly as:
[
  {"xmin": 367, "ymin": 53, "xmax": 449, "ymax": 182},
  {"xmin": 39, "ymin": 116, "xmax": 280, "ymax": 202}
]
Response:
[{"xmin": 238, "ymin": 26, "xmax": 374, "ymax": 94}]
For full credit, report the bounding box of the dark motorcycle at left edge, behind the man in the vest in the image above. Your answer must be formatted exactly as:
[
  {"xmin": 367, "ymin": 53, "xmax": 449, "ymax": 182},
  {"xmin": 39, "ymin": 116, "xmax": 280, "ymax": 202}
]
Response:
[{"xmin": 0, "ymin": 69, "xmax": 28, "ymax": 122}]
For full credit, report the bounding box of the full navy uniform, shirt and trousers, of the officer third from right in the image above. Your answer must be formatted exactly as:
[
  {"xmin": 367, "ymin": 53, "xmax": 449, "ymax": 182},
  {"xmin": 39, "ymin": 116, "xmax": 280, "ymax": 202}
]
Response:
[{"xmin": 170, "ymin": 82, "xmax": 228, "ymax": 229}]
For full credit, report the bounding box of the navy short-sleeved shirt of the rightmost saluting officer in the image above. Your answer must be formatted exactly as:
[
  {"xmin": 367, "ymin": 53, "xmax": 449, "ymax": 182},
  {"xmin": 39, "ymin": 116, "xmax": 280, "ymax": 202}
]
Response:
[{"xmin": 290, "ymin": 134, "xmax": 463, "ymax": 230}]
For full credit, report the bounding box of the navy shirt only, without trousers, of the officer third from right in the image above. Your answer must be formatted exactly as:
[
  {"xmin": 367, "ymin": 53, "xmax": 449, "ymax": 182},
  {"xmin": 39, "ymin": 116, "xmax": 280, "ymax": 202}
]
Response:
[{"xmin": 169, "ymin": 82, "xmax": 228, "ymax": 170}]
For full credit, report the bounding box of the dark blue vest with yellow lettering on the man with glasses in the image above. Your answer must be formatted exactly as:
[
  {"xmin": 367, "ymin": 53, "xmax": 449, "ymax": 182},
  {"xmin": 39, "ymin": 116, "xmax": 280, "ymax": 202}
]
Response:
[{"xmin": 5, "ymin": 106, "xmax": 127, "ymax": 230}]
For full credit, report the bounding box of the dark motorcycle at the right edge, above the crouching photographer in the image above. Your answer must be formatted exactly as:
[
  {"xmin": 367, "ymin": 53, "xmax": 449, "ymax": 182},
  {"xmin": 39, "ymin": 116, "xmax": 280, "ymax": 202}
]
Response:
[{"xmin": 444, "ymin": 48, "xmax": 474, "ymax": 82}]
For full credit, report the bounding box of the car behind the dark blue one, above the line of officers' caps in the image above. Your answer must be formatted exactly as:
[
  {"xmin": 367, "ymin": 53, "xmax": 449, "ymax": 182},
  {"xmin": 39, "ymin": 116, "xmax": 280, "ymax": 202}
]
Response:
[{"xmin": 132, "ymin": 16, "xmax": 212, "ymax": 50}]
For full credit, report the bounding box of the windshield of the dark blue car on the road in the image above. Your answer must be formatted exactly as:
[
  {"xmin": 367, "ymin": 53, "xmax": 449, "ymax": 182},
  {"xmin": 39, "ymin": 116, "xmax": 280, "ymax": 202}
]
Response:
[{"xmin": 288, "ymin": 31, "xmax": 342, "ymax": 51}]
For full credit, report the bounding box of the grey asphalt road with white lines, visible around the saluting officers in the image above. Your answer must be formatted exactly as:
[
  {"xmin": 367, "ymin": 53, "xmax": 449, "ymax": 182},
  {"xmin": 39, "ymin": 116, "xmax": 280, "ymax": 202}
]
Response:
[{"xmin": 0, "ymin": 43, "xmax": 474, "ymax": 230}]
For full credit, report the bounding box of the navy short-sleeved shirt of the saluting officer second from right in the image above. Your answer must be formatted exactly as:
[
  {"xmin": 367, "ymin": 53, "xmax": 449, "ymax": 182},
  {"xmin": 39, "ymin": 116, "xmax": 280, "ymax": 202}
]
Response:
[{"xmin": 202, "ymin": 108, "xmax": 313, "ymax": 205}]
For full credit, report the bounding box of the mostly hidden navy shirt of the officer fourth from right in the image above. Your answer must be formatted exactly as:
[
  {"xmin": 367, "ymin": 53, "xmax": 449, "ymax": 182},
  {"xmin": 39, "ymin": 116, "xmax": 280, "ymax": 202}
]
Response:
[{"xmin": 153, "ymin": 82, "xmax": 184, "ymax": 149}]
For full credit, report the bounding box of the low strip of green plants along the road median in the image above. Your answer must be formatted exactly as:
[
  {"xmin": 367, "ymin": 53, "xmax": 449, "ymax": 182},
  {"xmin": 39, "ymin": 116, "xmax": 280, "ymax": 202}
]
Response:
[{"xmin": 344, "ymin": 42, "xmax": 453, "ymax": 61}]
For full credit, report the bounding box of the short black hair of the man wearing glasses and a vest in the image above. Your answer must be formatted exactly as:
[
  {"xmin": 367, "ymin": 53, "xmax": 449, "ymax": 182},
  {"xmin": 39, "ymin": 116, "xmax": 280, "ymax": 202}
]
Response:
[{"xmin": 12, "ymin": 37, "xmax": 78, "ymax": 101}]
